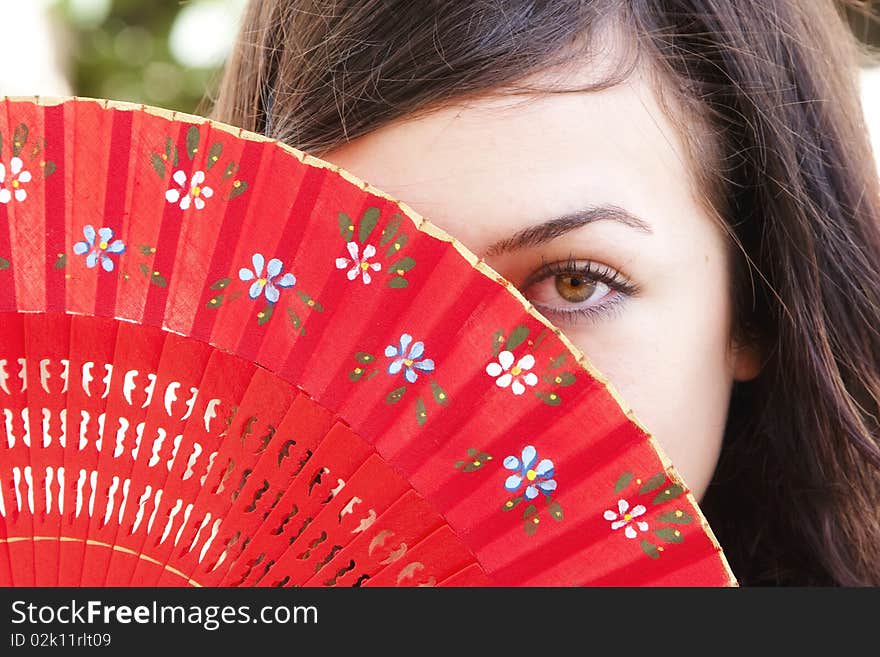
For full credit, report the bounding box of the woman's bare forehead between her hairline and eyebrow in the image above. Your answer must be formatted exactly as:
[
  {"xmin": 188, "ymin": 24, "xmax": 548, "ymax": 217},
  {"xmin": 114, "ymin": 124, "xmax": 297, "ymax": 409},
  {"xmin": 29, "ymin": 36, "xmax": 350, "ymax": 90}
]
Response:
[{"xmin": 325, "ymin": 61, "xmax": 696, "ymax": 251}]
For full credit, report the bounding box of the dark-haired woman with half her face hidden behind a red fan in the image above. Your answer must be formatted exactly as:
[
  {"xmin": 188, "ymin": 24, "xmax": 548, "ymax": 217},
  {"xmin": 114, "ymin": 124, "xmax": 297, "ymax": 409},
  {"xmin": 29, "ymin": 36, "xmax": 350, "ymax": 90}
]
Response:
[{"xmin": 212, "ymin": 0, "xmax": 880, "ymax": 585}]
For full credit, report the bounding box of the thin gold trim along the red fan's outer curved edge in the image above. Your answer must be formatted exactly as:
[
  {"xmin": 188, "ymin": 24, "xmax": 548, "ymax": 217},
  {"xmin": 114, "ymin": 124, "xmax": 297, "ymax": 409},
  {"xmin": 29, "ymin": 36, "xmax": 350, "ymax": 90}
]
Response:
[{"xmin": 0, "ymin": 96, "xmax": 739, "ymax": 586}]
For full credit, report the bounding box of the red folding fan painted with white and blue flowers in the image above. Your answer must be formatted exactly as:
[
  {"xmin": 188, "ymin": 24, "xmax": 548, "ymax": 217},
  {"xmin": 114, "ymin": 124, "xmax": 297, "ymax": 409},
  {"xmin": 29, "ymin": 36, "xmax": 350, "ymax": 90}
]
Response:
[{"xmin": 0, "ymin": 99, "xmax": 736, "ymax": 586}]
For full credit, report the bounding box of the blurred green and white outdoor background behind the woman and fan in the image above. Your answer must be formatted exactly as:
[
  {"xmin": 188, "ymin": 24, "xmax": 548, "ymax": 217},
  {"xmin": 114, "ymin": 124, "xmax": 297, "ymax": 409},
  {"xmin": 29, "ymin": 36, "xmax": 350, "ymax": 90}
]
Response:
[{"xmin": 6, "ymin": 0, "xmax": 880, "ymax": 117}]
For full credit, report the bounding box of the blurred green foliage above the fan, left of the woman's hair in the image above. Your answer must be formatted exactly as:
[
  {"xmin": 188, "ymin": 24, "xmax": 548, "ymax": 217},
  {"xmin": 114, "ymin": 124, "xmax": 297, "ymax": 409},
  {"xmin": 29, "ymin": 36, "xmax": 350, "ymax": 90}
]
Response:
[{"xmin": 50, "ymin": 0, "xmax": 234, "ymax": 113}]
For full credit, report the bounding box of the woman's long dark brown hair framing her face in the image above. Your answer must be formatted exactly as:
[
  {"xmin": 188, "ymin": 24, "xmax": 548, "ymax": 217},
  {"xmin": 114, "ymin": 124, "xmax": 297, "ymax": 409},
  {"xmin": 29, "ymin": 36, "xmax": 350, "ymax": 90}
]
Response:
[{"xmin": 211, "ymin": 0, "xmax": 880, "ymax": 585}]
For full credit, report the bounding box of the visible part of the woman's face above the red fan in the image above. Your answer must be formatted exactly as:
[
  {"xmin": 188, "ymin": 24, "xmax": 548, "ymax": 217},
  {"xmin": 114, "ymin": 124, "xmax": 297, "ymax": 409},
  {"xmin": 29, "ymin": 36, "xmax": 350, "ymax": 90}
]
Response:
[{"xmin": 321, "ymin": 62, "xmax": 754, "ymax": 499}]
